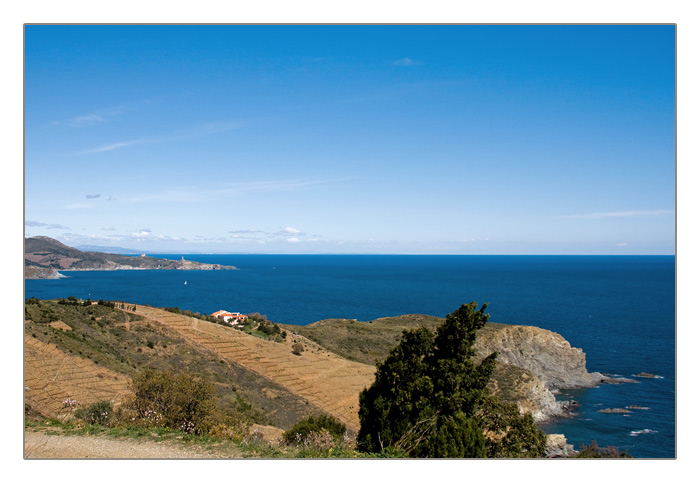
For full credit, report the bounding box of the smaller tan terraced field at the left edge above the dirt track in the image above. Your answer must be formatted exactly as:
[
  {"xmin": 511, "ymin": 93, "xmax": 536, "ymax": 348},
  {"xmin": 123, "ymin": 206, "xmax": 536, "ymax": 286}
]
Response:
[{"xmin": 24, "ymin": 335, "xmax": 131, "ymax": 417}]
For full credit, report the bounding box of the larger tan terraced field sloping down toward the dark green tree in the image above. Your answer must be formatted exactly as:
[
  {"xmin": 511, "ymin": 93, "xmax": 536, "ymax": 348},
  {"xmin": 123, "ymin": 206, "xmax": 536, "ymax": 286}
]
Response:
[{"xmin": 132, "ymin": 305, "xmax": 375, "ymax": 431}]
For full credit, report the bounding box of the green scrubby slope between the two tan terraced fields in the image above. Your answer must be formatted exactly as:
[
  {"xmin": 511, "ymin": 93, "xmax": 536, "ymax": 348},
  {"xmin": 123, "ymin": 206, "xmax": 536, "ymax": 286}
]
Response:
[{"xmin": 25, "ymin": 301, "xmax": 314, "ymax": 428}]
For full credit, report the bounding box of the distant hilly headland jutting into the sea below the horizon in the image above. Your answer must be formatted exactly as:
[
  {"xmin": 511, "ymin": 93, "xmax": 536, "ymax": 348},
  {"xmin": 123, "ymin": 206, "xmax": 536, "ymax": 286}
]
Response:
[{"xmin": 24, "ymin": 236, "xmax": 236, "ymax": 278}]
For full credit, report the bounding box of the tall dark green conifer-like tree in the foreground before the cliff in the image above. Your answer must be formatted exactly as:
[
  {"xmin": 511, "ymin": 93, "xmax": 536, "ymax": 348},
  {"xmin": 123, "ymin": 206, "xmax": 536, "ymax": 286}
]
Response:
[{"xmin": 357, "ymin": 302, "xmax": 496, "ymax": 458}]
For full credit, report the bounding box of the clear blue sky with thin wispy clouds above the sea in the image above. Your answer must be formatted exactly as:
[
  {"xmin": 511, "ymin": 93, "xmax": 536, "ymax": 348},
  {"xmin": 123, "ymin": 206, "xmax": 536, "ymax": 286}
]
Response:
[{"xmin": 24, "ymin": 25, "xmax": 675, "ymax": 254}]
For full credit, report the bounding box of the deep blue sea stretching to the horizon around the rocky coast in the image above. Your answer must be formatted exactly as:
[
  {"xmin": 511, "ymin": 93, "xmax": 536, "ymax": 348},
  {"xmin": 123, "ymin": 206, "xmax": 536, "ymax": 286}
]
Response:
[{"xmin": 25, "ymin": 255, "xmax": 676, "ymax": 458}]
